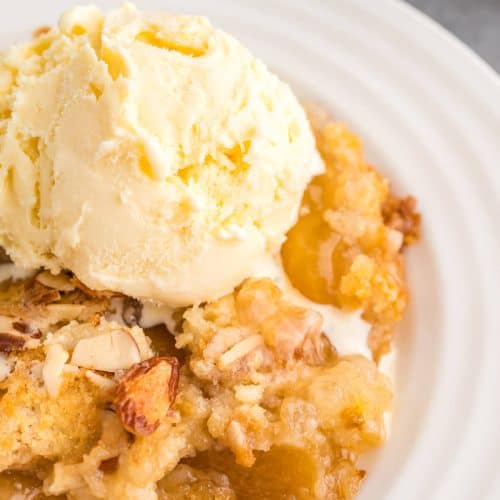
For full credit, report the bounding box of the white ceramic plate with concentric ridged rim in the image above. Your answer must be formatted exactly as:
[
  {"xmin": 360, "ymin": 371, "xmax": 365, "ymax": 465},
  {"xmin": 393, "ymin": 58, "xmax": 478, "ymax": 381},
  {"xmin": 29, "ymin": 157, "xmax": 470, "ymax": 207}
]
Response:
[{"xmin": 0, "ymin": 0, "xmax": 500, "ymax": 500}]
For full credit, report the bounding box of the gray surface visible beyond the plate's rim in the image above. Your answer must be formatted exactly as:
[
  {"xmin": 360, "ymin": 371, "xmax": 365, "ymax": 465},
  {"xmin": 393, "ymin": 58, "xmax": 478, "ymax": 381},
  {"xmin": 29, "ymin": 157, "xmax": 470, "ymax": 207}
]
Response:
[{"xmin": 407, "ymin": 0, "xmax": 500, "ymax": 73}]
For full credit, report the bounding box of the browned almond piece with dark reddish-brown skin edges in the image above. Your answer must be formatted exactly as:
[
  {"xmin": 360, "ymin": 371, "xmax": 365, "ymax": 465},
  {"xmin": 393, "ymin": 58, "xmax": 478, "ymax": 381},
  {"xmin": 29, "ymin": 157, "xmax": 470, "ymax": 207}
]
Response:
[{"xmin": 115, "ymin": 356, "xmax": 179, "ymax": 436}]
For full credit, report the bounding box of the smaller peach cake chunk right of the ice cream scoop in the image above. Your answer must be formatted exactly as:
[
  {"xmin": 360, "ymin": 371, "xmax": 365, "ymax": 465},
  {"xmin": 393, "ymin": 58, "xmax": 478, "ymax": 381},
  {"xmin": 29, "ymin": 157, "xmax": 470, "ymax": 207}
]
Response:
[{"xmin": 281, "ymin": 109, "xmax": 420, "ymax": 360}]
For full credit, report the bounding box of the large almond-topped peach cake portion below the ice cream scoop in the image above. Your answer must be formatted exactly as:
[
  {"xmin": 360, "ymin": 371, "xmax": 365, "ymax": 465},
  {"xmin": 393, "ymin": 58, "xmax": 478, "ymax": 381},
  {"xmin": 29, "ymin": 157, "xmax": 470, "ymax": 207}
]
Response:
[{"xmin": 0, "ymin": 272, "xmax": 392, "ymax": 499}]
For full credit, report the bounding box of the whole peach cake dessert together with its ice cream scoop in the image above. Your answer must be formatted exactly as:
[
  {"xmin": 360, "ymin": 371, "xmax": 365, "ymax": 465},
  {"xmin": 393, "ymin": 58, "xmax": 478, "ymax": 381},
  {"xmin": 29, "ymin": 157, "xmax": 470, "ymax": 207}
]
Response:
[{"xmin": 0, "ymin": 4, "xmax": 419, "ymax": 500}]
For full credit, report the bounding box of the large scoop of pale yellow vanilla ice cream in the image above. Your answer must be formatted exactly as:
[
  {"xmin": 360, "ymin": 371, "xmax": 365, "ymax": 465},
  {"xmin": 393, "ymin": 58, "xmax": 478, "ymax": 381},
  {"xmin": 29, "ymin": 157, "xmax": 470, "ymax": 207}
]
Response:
[{"xmin": 0, "ymin": 4, "xmax": 322, "ymax": 306}]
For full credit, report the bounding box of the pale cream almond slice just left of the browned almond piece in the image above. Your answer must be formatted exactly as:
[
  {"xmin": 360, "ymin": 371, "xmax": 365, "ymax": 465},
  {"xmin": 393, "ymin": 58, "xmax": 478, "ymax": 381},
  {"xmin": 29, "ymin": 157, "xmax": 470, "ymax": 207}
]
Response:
[{"xmin": 71, "ymin": 330, "xmax": 141, "ymax": 372}]
